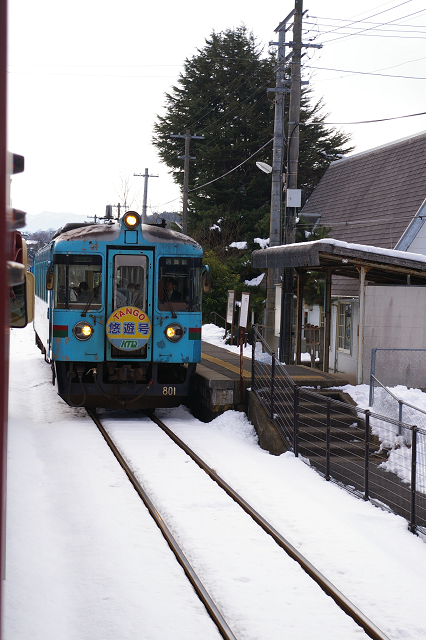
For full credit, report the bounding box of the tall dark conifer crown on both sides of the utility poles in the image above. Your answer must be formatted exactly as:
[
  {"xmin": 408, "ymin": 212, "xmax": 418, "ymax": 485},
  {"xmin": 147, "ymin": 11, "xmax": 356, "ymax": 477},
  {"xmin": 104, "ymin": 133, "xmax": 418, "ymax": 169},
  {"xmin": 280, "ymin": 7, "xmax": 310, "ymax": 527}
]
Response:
[{"xmin": 153, "ymin": 25, "xmax": 350, "ymax": 239}]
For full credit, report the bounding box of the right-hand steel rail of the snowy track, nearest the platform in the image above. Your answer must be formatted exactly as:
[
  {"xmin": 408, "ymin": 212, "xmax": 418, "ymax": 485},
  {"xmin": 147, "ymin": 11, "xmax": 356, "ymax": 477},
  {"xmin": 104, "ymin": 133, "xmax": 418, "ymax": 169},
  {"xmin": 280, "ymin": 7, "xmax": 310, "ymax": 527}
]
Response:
[{"xmin": 146, "ymin": 411, "xmax": 389, "ymax": 640}]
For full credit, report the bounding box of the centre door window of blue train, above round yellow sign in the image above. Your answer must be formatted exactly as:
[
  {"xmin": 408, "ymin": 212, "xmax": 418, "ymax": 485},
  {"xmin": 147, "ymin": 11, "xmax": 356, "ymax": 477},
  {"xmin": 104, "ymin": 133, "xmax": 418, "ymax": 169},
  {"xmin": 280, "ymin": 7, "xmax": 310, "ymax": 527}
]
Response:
[{"xmin": 114, "ymin": 254, "xmax": 148, "ymax": 311}]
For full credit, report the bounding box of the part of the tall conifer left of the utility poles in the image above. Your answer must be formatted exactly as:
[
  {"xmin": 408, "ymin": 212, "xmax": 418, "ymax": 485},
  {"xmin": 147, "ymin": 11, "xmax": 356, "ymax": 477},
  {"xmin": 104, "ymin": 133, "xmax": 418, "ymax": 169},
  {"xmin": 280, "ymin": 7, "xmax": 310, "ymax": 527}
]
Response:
[{"xmin": 153, "ymin": 26, "xmax": 274, "ymax": 238}]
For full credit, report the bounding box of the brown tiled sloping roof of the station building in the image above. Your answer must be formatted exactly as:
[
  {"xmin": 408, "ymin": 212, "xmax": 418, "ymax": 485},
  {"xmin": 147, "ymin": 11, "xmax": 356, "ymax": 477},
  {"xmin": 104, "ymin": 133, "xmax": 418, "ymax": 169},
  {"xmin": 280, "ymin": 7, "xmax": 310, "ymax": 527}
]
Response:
[{"xmin": 300, "ymin": 132, "xmax": 426, "ymax": 296}]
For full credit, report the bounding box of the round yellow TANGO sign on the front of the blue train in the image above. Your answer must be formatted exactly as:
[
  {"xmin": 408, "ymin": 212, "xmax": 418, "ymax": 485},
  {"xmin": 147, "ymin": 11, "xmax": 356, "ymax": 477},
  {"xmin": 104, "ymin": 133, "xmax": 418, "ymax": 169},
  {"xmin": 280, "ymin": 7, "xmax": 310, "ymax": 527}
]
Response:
[{"xmin": 106, "ymin": 307, "xmax": 151, "ymax": 351}]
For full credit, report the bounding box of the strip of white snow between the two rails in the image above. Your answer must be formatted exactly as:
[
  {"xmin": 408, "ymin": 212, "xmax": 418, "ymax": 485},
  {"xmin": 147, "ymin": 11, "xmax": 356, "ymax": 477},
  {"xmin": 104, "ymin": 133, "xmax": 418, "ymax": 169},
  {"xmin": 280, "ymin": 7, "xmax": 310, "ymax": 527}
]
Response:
[{"xmin": 102, "ymin": 408, "xmax": 365, "ymax": 640}]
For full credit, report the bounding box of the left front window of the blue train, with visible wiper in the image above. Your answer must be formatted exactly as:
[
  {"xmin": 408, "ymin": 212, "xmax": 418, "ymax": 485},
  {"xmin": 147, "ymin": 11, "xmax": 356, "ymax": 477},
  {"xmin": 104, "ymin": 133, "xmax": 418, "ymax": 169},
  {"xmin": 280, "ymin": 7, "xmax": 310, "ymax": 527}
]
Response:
[{"xmin": 53, "ymin": 254, "xmax": 102, "ymax": 309}]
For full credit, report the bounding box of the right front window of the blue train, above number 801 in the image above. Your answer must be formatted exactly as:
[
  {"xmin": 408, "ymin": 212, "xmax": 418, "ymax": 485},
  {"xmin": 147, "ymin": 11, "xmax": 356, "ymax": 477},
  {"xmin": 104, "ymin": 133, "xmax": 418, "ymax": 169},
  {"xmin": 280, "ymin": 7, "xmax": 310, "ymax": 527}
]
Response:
[{"xmin": 158, "ymin": 257, "xmax": 202, "ymax": 311}]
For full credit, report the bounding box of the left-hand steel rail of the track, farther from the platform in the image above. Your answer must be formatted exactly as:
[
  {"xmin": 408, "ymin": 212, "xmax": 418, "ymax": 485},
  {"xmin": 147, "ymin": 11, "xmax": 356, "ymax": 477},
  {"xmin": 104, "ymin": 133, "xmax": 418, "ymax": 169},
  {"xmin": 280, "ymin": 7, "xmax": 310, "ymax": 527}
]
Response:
[{"xmin": 86, "ymin": 409, "xmax": 237, "ymax": 640}]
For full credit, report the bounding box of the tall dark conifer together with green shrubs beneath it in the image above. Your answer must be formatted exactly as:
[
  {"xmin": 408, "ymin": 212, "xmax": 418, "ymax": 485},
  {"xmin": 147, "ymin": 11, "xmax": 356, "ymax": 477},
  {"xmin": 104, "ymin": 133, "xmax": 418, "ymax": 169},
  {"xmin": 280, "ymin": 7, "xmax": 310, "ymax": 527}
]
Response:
[{"xmin": 153, "ymin": 25, "xmax": 351, "ymax": 322}]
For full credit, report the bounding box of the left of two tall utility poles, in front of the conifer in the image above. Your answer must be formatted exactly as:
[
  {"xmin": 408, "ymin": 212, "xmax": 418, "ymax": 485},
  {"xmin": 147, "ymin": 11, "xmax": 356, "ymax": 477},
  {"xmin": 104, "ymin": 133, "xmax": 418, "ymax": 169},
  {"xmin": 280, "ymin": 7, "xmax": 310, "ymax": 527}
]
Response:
[{"xmin": 265, "ymin": 10, "xmax": 295, "ymax": 352}]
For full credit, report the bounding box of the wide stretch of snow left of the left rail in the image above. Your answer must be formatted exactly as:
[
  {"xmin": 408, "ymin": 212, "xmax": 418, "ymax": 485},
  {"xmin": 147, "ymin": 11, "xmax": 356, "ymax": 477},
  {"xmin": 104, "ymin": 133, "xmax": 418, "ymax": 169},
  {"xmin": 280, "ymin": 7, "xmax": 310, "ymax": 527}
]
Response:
[{"xmin": 3, "ymin": 328, "xmax": 220, "ymax": 640}]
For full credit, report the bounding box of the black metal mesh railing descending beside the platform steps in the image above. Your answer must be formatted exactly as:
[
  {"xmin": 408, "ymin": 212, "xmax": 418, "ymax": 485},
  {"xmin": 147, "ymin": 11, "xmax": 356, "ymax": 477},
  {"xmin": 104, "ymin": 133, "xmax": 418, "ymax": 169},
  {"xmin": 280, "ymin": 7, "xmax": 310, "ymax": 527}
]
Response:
[{"xmin": 252, "ymin": 327, "xmax": 426, "ymax": 533}]
